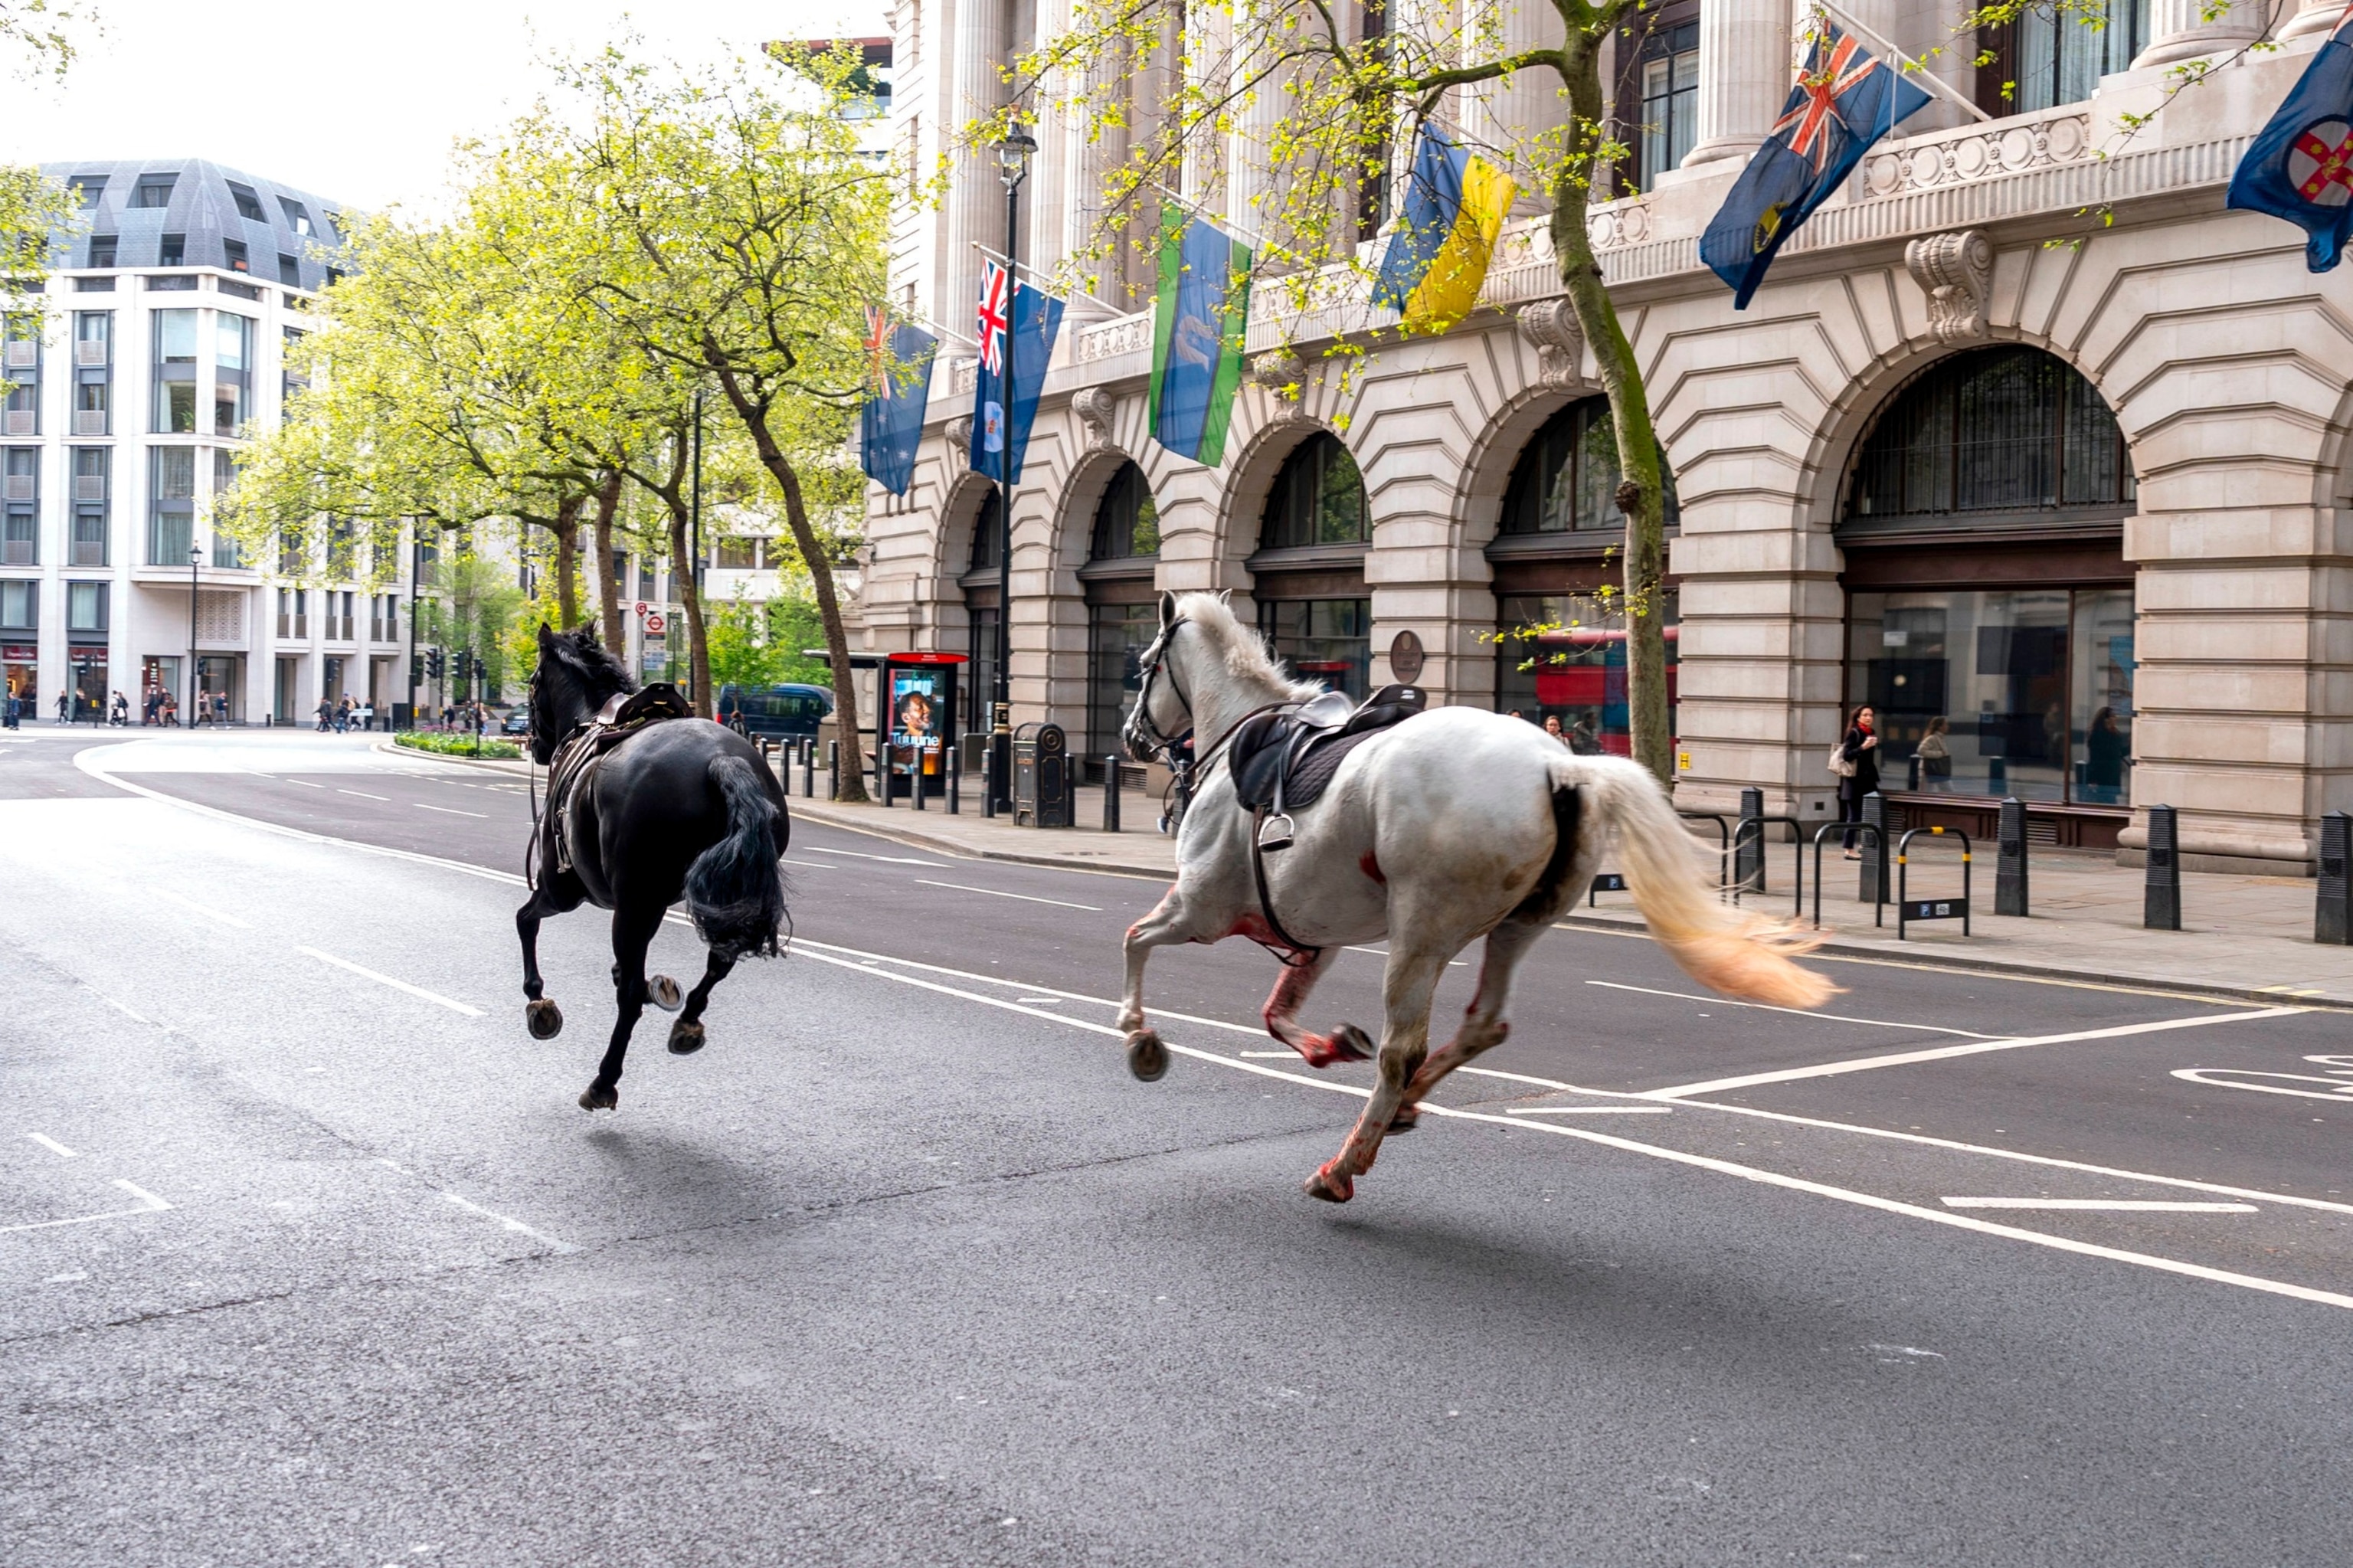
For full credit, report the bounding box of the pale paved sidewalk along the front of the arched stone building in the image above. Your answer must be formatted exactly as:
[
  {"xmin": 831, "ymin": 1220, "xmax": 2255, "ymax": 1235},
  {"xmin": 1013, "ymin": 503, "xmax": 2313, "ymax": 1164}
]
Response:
[{"xmin": 771, "ymin": 774, "xmax": 2353, "ymax": 1007}]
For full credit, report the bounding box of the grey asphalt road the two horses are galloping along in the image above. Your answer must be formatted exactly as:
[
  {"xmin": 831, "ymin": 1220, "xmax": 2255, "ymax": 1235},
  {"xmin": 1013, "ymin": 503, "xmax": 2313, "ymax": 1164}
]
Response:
[{"xmin": 0, "ymin": 730, "xmax": 2353, "ymax": 1566}]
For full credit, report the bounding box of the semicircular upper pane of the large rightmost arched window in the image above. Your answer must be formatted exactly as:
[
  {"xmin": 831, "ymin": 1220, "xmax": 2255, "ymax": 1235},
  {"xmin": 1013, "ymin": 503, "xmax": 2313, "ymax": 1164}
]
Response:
[{"xmin": 1842, "ymin": 349, "xmax": 2134, "ymax": 530}]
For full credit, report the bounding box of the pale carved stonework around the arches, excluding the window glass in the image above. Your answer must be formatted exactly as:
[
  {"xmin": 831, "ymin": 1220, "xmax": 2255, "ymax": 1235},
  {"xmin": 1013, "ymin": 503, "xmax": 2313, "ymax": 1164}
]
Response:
[{"xmin": 866, "ymin": 0, "xmax": 2353, "ymax": 871}]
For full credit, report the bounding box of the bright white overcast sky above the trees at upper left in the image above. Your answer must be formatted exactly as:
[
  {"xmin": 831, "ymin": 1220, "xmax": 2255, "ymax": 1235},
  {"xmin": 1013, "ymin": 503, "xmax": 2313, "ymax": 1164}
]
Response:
[{"xmin": 0, "ymin": 0, "xmax": 887, "ymax": 210}]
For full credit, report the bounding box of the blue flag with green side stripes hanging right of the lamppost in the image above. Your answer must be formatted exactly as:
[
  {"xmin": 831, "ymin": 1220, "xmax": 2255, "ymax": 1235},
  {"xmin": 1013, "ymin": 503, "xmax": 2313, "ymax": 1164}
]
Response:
[{"xmin": 1148, "ymin": 205, "xmax": 1249, "ymax": 469}]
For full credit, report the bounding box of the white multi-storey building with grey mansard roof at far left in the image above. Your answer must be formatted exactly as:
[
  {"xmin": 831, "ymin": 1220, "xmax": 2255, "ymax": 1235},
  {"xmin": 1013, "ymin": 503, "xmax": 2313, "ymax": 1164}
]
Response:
[{"xmin": 0, "ymin": 160, "xmax": 410, "ymax": 723}]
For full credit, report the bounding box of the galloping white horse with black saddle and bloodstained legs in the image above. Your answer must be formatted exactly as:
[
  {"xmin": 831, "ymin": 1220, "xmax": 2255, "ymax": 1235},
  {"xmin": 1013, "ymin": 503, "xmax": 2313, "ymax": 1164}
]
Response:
[{"xmin": 1120, "ymin": 594, "xmax": 1835, "ymax": 1203}]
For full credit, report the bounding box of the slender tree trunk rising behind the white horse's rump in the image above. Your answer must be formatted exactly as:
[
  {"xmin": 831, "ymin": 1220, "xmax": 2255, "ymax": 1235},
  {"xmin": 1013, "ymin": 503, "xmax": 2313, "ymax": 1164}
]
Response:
[{"xmin": 1553, "ymin": 28, "xmax": 1675, "ymax": 789}]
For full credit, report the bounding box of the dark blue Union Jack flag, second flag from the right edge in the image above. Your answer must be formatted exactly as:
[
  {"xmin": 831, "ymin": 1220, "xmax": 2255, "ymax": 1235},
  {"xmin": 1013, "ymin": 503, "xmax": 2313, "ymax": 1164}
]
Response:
[{"xmin": 1699, "ymin": 21, "xmax": 1927, "ymax": 311}]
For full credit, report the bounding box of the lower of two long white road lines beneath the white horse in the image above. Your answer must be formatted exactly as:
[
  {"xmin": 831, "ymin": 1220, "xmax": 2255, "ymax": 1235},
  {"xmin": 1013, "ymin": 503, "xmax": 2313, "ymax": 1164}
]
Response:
[{"xmin": 786, "ymin": 949, "xmax": 2353, "ymax": 1311}]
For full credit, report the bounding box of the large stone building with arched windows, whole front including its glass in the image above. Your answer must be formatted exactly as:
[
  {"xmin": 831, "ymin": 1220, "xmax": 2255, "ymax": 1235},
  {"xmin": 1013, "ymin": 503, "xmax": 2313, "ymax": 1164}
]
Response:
[{"xmin": 863, "ymin": 0, "xmax": 2353, "ymax": 873}]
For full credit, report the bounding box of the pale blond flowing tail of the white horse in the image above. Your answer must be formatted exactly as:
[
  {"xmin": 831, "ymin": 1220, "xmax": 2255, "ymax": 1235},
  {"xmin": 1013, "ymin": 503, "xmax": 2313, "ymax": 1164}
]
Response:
[{"xmin": 1553, "ymin": 756, "xmax": 1840, "ymax": 1007}]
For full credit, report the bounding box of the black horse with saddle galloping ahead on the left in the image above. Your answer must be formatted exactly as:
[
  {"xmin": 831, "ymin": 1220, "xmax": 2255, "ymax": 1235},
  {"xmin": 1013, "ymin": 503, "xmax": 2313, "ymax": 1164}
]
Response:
[{"xmin": 515, "ymin": 627, "xmax": 793, "ymax": 1111}]
